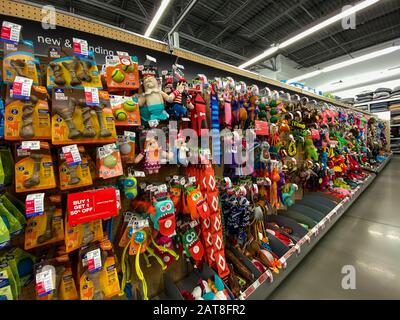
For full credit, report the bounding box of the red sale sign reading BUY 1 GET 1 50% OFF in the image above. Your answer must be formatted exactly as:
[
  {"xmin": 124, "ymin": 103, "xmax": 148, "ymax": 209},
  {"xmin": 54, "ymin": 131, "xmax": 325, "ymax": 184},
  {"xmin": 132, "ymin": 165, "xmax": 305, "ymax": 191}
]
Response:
[{"xmin": 67, "ymin": 188, "xmax": 118, "ymax": 225}]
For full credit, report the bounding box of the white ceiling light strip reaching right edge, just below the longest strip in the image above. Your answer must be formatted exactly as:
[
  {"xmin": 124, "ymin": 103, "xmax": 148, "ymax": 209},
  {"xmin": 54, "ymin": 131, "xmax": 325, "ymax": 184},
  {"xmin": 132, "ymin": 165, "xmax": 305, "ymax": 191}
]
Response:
[{"xmin": 287, "ymin": 46, "xmax": 400, "ymax": 83}]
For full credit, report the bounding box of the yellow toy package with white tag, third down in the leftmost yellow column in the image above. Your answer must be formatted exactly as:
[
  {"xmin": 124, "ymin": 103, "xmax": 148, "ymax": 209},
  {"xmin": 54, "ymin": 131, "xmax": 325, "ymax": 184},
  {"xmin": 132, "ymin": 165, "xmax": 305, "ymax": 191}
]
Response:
[{"xmin": 15, "ymin": 141, "xmax": 56, "ymax": 192}]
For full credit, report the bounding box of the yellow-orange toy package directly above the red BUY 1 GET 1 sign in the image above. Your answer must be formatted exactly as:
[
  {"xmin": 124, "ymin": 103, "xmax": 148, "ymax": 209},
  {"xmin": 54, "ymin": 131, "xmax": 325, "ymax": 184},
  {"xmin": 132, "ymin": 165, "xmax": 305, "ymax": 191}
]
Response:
[{"xmin": 58, "ymin": 146, "xmax": 93, "ymax": 190}]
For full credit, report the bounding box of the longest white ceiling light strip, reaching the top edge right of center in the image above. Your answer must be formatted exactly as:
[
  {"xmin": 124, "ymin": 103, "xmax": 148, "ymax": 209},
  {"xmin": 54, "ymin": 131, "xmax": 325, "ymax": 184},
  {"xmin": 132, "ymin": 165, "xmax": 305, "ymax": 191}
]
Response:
[{"xmin": 239, "ymin": 0, "xmax": 379, "ymax": 69}]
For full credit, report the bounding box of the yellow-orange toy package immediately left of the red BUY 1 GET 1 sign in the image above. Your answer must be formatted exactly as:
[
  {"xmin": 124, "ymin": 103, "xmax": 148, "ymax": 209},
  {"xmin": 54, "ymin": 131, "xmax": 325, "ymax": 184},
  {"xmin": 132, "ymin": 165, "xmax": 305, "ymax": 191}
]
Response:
[{"xmin": 25, "ymin": 204, "xmax": 64, "ymax": 250}]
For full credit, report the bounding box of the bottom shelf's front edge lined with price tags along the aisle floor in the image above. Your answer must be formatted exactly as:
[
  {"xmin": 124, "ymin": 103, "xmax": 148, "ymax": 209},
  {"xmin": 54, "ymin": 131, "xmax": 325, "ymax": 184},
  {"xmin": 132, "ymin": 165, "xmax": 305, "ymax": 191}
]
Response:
[{"xmin": 241, "ymin": 154, "xmax": 392, "ymax": 300}]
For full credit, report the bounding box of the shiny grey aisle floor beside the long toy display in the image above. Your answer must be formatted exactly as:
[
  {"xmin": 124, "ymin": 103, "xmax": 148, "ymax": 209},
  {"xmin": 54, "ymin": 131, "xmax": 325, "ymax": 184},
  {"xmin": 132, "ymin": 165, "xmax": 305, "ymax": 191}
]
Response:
[{"xmin": 270, "ymin": 157, "xmax": 400, "ymax": 299}]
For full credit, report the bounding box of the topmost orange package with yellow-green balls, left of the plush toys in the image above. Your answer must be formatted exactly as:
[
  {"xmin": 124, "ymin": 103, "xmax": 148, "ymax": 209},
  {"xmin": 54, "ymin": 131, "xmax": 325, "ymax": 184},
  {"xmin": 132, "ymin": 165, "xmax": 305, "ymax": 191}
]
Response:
[{"xmin": 105, "ymin": 54, "xmax": 140, "ymax": 92}]
